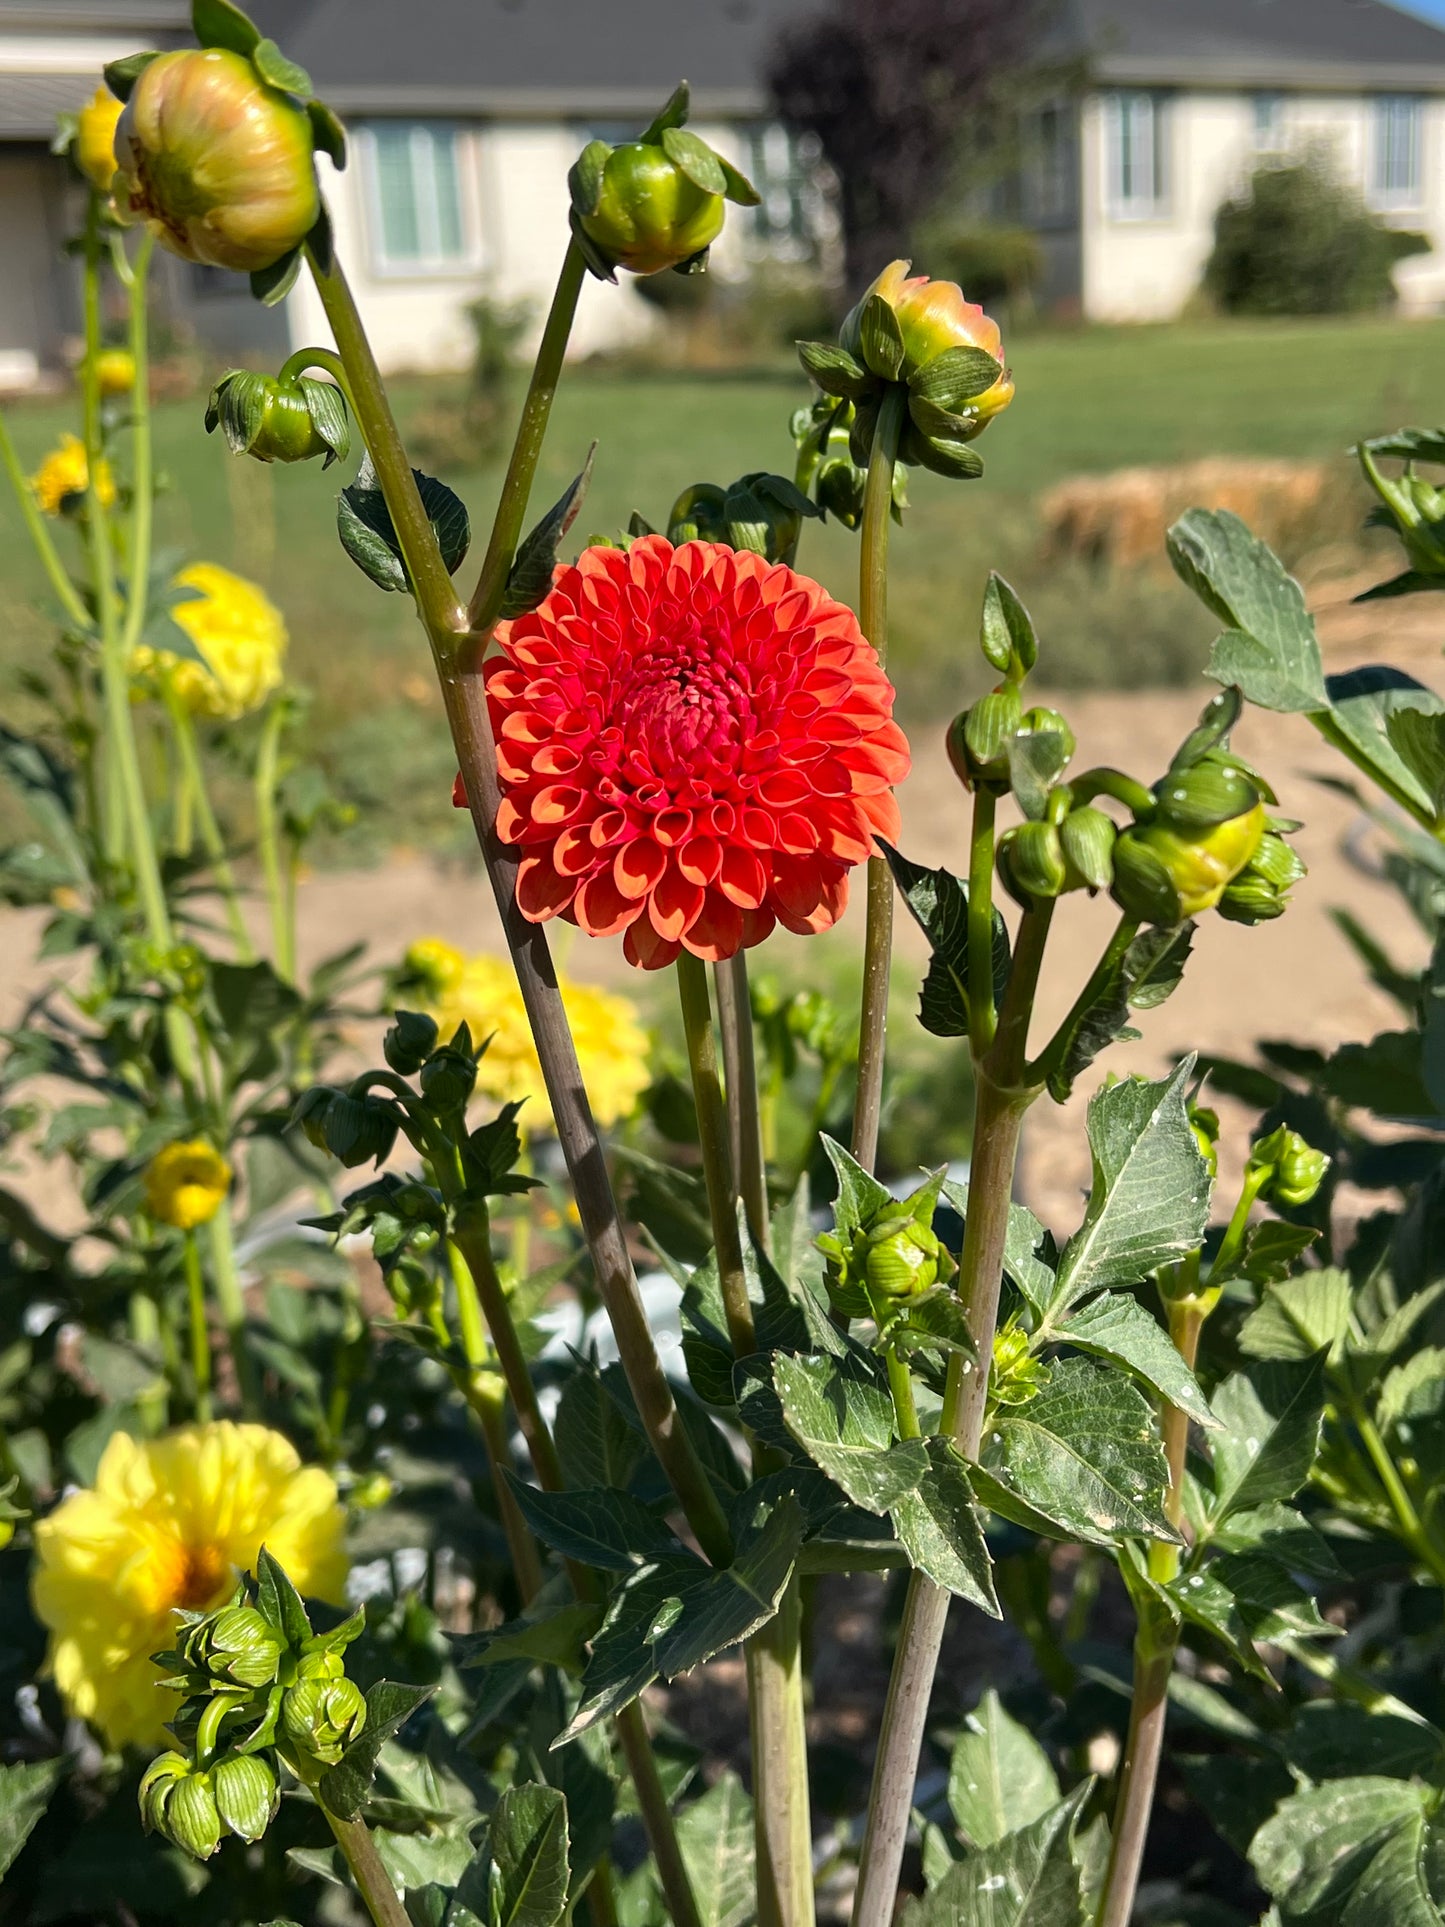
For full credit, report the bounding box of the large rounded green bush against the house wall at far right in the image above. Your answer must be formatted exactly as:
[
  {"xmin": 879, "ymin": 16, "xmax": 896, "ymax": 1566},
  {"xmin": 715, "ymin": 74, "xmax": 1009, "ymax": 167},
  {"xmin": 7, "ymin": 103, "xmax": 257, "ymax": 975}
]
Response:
[{"xmin": 1204, "ymin": 158, "xmax": 1430, "ymax": 314}]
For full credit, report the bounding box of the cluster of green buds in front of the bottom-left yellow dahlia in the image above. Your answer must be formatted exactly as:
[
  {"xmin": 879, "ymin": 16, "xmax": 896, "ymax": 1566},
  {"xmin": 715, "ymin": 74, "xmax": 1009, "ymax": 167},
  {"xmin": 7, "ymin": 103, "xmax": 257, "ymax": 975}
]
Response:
[{"xmin": 139, "ymin": 1551, "xmax": 368, "ymax": 1860}]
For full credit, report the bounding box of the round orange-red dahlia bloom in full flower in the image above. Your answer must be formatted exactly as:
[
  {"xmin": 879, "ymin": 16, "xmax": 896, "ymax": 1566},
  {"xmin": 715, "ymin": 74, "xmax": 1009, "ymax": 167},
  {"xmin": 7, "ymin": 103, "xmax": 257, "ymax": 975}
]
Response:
[{"xmin": 487, "ymin": 536, "xmax": 909, "ymax": 969}]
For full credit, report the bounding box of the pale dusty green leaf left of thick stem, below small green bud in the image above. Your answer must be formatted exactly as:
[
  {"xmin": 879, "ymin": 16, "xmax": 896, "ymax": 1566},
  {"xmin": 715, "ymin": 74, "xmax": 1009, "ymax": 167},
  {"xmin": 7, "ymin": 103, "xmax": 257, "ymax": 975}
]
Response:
[{"xmin": 773, "ymin": 1355, "xmax": 929, "ymax": 1513}]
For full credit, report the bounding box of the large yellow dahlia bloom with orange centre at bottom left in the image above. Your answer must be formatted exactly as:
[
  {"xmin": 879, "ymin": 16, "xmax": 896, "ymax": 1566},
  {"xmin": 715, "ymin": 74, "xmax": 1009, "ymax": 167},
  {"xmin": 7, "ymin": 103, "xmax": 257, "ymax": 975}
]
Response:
[{"xmin": 33, "ymin": 1420, "xmax": 347, "ymax": 1746}]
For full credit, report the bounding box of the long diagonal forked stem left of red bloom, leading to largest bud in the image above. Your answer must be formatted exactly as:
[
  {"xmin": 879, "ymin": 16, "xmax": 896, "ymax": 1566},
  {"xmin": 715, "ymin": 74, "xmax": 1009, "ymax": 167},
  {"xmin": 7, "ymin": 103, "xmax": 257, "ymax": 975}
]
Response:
[{"xmin": 312, "ymin": 237, "xmax": 732, "ymax": 1565}]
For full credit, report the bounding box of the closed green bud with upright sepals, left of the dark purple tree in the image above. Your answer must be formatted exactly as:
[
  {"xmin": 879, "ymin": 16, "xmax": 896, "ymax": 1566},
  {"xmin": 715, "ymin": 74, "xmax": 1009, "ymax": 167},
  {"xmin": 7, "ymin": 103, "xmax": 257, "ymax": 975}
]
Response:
[{"xmin": 566, "ymin": 81, "xmax": 757, "ymax": 281}]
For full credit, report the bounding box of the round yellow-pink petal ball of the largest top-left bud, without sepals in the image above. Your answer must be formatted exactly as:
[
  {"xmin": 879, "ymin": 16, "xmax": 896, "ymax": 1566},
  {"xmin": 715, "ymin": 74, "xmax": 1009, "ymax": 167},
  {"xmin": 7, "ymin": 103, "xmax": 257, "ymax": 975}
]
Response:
[{"xmin": 116, "ymin": 46, "xmax": 320, "ymax": 274}]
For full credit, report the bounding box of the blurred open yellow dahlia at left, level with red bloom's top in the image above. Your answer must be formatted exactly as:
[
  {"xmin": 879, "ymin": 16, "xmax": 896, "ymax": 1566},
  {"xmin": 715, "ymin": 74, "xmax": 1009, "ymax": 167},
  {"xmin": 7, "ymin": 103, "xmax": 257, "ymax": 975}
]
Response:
[{"xmin": 131, "ymin": 563, "xmax": 289, "ymax": 721}]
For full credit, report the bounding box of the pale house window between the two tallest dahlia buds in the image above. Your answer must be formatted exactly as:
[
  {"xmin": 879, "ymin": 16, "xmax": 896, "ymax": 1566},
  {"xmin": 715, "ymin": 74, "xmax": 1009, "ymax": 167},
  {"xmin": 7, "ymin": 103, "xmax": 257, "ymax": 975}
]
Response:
[{"xmin": 366, "ymin": 121, "xmax": 478, "ymax": 274}]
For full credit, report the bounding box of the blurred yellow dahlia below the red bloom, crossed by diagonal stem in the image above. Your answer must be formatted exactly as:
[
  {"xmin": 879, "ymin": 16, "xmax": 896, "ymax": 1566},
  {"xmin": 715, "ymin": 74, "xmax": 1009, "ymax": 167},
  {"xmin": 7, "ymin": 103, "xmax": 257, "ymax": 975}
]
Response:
[{"xmin": 407, "ymin": 937, "xmax": 651, "ymax": 1131}]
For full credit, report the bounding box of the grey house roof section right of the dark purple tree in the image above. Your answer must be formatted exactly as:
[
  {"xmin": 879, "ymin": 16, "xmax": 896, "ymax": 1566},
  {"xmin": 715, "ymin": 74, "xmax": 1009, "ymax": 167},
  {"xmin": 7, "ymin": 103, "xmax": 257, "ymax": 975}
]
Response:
[{"xmin": 1069, "ymin": 0, "xmax": 1445, "ymax": 92}]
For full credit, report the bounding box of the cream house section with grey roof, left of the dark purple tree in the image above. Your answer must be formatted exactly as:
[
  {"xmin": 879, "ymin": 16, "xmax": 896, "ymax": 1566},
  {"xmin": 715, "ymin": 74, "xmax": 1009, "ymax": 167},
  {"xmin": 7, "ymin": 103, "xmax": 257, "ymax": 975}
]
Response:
[{"xmin": 0, "ymin": 0, "xmax": 836, "ymax": 385}]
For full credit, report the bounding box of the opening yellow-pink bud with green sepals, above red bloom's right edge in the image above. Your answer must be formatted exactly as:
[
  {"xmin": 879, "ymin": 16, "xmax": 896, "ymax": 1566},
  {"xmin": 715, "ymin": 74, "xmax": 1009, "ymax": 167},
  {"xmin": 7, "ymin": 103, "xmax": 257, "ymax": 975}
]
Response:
[{"xmin": 798, "ymin": 260, "xmax": 1013, "ymax": 480}]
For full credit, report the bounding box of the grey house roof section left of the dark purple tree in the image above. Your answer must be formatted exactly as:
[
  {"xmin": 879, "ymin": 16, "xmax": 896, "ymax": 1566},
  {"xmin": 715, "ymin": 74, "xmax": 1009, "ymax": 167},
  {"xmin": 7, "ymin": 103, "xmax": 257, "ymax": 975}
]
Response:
[{"xmin": 250, "ymin": 0, "xmax": 823, "ymax": 121}]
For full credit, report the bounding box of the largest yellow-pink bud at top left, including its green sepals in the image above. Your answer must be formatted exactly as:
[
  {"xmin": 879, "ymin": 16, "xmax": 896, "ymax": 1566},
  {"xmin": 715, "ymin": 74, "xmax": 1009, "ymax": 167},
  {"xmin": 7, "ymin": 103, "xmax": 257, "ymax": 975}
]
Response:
[{"xmin": 102, "ymin": 4, "xmax": 345, "ymax": 299}]
